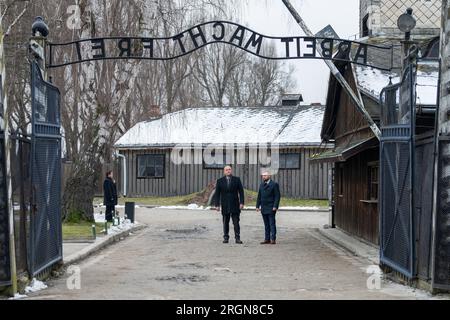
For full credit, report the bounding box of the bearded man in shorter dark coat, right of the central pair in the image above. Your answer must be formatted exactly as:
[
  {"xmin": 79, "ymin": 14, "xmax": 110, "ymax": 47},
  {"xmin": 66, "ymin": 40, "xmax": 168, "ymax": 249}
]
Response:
[{"xmin": 256, "ymin": 172, "xmax": 281, "ymax": 244}]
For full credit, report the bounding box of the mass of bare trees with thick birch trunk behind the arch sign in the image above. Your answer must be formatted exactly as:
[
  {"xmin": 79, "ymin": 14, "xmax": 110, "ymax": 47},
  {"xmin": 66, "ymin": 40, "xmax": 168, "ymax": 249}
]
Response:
[{"xmin": 0, "ymin": 0, "xmax": 291, "ymax": 220}]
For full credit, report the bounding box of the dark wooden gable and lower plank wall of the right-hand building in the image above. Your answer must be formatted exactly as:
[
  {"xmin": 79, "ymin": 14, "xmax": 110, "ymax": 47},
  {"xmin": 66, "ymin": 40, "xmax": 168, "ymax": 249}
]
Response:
[{"xmin": 324, "ymin": 67, "xmax": 379, "ymax": 245}]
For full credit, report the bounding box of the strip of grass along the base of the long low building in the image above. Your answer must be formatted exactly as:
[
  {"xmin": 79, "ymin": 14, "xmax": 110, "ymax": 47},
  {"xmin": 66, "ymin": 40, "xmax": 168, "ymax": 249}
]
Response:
[{"xmin": 94, "ymin": 190, "xmax": 329, "ymax": 208}]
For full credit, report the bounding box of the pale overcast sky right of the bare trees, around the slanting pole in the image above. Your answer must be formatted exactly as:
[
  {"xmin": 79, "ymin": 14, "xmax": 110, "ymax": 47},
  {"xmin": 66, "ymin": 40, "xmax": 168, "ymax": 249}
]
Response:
[{"xmin": 236, "ymin": 0, "xmax": 359, "ymax": 103}]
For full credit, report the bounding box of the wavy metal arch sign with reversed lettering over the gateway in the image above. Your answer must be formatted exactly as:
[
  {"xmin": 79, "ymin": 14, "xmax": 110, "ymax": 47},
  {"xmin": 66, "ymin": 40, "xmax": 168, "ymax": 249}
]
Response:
[{"xmin": 46, "ymin": 21, "xmax": 393, "ymax": 70}]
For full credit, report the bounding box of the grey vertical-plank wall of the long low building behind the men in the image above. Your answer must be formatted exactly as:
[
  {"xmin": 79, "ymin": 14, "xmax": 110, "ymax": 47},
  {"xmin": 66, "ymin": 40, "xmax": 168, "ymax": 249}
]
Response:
[{"xmin": 121, "ymin": 148, "xmax": 331, "ymax": 199}]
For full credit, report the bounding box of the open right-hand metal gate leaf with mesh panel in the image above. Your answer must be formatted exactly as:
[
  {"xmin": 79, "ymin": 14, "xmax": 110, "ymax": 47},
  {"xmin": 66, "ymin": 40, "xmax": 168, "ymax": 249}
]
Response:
[{"xmin": 380, "ymin": 64, "xmax": 416, "ymax": 278}]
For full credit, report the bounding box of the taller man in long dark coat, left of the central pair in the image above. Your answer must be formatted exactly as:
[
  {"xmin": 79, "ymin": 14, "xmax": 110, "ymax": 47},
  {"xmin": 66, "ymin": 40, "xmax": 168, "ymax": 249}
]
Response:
[{"xmin": 214, "ymin": 166, "xmax": 244, "ymax": 244}]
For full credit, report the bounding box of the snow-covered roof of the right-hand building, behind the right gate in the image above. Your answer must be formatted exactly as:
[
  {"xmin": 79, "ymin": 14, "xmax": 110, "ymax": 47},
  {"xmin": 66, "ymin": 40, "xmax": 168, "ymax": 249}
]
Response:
[{"xmin": 355, "ymin": 63, "xmax": 439, "ymax": 106}]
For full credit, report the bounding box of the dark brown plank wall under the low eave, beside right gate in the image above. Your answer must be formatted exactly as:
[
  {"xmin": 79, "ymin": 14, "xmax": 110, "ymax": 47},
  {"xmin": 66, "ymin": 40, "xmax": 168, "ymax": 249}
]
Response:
[{"xmin": 334, "ymin": 148, "xmax": 379, "ymax": 244}]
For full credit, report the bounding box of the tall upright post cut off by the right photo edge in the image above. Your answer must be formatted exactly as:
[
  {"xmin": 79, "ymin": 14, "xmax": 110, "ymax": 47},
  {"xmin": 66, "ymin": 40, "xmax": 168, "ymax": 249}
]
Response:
[{"xmin": 432, "ymin": 0, "xmax": 450, "ymax": 290}]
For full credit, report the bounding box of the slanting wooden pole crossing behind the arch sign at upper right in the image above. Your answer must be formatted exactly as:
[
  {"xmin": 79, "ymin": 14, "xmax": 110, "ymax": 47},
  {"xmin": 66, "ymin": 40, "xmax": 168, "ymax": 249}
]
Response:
[{"xmin": 282, "ymin": 0, "xmax": 381, "ymax": 140}]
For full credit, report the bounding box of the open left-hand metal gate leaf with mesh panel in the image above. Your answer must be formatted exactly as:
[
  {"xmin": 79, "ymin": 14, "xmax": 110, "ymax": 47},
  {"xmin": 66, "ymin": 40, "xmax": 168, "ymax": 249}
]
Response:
[{"xmin": 28, "ymin": 62, "xmax": 62, "ymax": 276}]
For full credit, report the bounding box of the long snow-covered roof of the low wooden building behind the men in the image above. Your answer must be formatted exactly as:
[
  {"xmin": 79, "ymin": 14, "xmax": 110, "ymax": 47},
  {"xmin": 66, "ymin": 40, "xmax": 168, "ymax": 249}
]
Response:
[{"xmin": 115, "ymin": 106, "xmax": 325, "ymax": 149}]
